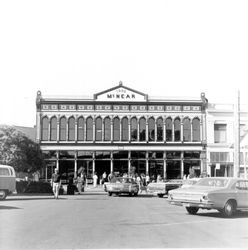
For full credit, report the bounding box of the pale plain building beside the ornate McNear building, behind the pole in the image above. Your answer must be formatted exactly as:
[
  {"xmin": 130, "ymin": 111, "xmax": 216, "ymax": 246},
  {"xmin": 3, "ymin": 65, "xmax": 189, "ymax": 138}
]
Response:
[{"xmin": 206, "ymin": 102, "xmax": 248, "ymax": 177}]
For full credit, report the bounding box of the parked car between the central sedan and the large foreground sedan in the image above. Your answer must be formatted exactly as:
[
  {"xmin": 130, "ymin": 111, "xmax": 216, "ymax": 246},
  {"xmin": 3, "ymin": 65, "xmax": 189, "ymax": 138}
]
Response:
[{"xmin": 147, "ymin": 179, "xmax": 183, "ymax": 198}]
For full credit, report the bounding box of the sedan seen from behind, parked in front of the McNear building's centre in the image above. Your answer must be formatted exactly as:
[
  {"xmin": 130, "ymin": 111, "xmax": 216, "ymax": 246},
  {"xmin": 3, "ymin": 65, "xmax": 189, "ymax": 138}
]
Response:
[{"xmin": 106, "ymin": 177, "xmax": 139, "ymax": 196}]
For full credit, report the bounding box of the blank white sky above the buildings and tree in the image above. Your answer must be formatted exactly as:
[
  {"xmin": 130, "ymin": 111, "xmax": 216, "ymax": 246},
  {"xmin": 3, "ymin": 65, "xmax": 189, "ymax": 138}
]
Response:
[{"xmin": 0, "ymin": 0, "xmax": 248, "ymax": 127}]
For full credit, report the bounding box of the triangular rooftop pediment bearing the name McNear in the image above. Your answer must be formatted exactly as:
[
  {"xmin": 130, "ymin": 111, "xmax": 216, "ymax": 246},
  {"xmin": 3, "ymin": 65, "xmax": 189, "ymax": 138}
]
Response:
[{"xmin": 94, "ymin": 82, "xmax": 147, "ymax": 102}]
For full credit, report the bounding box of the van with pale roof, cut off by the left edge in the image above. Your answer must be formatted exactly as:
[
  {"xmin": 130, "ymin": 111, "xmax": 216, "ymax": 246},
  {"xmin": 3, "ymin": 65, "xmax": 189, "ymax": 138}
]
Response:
[{"xmin": 0, "ymin": 165, "xmax": 16, "ymax": 200}]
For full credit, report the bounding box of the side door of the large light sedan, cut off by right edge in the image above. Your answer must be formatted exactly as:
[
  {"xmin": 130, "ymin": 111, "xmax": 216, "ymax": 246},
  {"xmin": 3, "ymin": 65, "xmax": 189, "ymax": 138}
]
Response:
[{"xmin": 235, "ymin": 180, "xmax": 248, "ymax": 209}]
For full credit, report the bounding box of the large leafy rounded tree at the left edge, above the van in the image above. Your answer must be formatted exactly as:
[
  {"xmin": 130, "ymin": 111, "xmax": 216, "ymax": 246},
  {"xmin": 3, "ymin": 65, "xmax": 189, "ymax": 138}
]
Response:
[{"xmin": 0, "ymin": 126, "xmax": 44, "ymax": 173}]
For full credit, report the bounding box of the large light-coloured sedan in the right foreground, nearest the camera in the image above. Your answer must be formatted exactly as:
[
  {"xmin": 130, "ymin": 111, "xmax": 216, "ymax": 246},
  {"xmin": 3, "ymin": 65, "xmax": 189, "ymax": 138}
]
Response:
[{"xmin": 167, "ymin": 177, "xmax": 248, "ymax": 217}]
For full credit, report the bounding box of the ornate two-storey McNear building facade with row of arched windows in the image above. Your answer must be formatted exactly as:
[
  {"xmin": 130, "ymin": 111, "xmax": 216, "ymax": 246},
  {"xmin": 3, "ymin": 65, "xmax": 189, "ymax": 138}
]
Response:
[{"xmin": 36, "ymin": 82, "xmax": 207, "ymax": 182}]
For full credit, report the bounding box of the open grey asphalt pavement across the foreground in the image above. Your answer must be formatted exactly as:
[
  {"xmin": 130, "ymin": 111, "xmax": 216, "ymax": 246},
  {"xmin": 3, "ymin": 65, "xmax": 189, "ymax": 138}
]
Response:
[{"xmin": 0, "ymin": 189, "xmax": 248, "ymax": 249}]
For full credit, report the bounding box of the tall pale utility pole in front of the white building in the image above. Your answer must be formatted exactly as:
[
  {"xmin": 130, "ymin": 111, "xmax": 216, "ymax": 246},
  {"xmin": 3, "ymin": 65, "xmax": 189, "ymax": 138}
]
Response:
[{"xmin": 233, "ymin": 90, "xmax": 240, "ymax": 177}]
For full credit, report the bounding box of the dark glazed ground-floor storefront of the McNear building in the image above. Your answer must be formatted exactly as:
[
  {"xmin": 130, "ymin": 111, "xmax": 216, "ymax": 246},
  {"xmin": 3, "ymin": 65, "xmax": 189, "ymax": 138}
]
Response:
[{"xmin": 43, "ymin": 150, "xmax": 204, "ymax": 183}]
